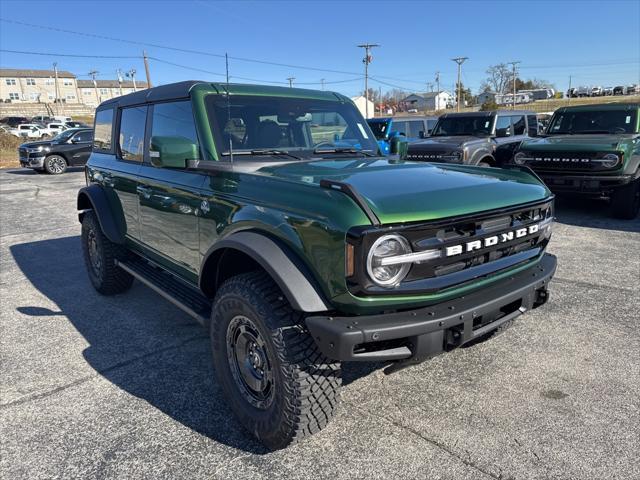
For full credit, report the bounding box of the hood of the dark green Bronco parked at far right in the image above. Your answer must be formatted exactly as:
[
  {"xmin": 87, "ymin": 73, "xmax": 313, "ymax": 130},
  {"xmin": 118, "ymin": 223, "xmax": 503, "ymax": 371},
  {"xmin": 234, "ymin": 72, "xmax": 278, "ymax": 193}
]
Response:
[{"xmin": 520, "ymin": 134, "xmax": 634, "ymax": 152}]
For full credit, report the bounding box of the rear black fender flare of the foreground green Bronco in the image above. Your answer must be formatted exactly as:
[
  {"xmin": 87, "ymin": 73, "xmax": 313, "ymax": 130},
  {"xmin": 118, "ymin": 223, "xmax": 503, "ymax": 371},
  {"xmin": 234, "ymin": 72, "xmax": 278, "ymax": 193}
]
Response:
[{"xmin": 77, "ymin": 184, "xmax": 126, "ymax": 244}]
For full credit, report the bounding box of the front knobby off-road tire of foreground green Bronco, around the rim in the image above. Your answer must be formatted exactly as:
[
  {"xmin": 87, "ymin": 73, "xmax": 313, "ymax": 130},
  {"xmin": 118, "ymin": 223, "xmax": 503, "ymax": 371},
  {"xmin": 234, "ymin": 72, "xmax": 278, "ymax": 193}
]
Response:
[{"xmin": 211, "ymin": 271, "xmax": 342, "ymax": 450}]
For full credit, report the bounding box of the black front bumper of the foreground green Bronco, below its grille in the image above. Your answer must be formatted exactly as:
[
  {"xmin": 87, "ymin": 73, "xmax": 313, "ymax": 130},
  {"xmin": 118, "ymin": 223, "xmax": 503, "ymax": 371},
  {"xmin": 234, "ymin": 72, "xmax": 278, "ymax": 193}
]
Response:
[{"xmin": 306, "ymin": 254, "xmax": 557, "ymax": 361}]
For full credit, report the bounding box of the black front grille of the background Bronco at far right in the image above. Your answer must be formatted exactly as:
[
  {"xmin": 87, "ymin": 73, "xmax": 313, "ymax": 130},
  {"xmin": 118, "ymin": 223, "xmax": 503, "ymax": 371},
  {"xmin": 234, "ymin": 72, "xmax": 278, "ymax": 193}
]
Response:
[{"xmin": 523, "ymin": 151, "xmax": 620, "ymax": 173}]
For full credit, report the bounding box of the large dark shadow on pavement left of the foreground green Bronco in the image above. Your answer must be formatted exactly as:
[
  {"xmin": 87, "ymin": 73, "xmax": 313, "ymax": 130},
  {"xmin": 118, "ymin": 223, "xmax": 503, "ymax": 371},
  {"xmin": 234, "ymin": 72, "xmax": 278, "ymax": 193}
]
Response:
[{"xmin": 11, "ymin": 237, "xmax": 267, "ymax": 454}]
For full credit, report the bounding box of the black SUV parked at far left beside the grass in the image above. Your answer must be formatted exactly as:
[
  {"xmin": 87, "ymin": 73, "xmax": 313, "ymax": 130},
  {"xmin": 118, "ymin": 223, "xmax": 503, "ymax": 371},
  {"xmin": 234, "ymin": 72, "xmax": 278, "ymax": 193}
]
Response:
[{"xmin": 18, "ymin": 128, "xmax": 93, "ymax": 175}]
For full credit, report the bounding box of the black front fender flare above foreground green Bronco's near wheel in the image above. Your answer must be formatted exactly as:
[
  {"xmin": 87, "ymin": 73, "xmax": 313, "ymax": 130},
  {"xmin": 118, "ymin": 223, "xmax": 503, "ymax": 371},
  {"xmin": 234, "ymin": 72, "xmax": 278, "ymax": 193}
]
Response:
[{"xmin": 199, "ymin": 231, "xmax": 331, "ymax": 312}]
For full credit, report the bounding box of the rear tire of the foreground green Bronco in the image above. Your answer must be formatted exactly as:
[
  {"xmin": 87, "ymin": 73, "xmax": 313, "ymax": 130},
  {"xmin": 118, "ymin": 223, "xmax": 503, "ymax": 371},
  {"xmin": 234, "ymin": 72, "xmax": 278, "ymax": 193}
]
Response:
[{"xmin": 81, "ymin": 211, "xmax": 133, "ymax": 295}]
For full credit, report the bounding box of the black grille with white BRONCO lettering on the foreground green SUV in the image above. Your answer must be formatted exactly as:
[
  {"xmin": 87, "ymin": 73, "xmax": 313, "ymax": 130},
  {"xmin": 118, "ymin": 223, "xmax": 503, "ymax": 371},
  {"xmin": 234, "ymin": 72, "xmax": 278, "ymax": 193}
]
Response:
[{"xmin": 348, "ymin": 201, "xmax": 553, "ymax": 295}]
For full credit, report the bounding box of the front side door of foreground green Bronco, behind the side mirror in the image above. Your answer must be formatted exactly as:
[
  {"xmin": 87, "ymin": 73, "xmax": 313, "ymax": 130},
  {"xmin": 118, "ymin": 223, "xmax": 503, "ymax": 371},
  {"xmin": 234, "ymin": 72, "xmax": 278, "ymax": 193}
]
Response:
[{"xmin": 139, "ymin": 100, "xmax": 206, "ymax": 280}]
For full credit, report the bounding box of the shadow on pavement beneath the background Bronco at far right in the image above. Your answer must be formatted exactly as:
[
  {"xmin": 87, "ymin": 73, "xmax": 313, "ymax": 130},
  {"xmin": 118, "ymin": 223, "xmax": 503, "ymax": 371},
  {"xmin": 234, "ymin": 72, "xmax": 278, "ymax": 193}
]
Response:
[{"xmin": 556, "ymin": 197, "xmax": 640, "ymax": 232}]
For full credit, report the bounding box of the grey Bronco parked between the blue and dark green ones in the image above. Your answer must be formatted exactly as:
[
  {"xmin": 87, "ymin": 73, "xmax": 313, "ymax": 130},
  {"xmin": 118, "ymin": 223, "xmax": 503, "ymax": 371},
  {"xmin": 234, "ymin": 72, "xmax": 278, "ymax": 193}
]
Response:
[{"xmin": 406, "ymin": 110, "xmax": 538, "ymax": 167}]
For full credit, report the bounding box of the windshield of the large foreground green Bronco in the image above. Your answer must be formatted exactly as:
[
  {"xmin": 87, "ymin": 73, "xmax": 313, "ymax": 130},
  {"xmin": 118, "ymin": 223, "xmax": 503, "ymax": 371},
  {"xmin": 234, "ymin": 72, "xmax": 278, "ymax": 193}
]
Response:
[{"xmin": 207, "ymin": 95, "xmax": 378, "ymax": 157}]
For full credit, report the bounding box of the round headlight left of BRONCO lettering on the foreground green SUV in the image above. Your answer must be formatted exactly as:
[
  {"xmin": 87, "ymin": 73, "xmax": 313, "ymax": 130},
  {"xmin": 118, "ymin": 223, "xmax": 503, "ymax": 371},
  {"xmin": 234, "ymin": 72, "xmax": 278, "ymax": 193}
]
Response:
[{"xmin": 367, "ymin": 235, "xmax": 411, "ymax": 287}]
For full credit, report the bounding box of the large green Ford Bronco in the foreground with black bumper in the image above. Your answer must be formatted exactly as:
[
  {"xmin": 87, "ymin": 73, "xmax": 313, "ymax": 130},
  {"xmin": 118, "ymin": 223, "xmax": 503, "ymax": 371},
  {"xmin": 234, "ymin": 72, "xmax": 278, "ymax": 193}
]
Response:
[{"xmin": 77, "ymin": 82, "xmax": 556, "ymax": 449}]
